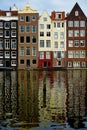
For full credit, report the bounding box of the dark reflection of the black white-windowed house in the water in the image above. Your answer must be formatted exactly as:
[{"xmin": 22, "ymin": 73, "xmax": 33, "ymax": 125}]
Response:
[{"xmin": 0, "ymin": 71, "xmax": 17, "ymax": 119}]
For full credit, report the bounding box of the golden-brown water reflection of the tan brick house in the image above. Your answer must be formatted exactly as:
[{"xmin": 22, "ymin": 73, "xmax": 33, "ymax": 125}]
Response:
[{"xmin": 18, "ymin": 70, "xmax": 39, "ymax": 123}]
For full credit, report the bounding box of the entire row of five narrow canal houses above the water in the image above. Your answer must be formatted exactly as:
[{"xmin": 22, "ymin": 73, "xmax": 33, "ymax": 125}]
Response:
[{"xmin": 0, "ymin": 3, "xmax": 87, "ymax": 69}]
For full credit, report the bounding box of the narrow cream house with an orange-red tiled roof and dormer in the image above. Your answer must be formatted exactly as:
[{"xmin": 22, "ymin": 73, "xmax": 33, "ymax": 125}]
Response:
[{"xmin": 51, "ymin": 11, "xmax": 66, "ymax": 67}]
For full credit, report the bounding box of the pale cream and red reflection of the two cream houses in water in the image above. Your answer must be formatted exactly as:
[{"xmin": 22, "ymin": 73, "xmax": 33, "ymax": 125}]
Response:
[{"xmin": 39, "ymin": 71, "xmax": 66, "ymax": 122}]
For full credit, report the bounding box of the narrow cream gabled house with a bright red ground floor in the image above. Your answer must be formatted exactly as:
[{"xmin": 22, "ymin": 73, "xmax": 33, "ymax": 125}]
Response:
[{"xmin": 38, "ymin": 10, "xmax": 53, "ymax": 68}]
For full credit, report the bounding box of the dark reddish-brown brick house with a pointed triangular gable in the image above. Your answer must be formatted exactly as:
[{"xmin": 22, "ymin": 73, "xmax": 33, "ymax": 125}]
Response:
[{"xmin": 66, "ymin": 3, "xmax": 87, "ymax": 68}]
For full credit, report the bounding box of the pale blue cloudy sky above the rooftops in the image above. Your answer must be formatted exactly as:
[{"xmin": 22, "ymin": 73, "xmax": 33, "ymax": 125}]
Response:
[{"xmin": 0, "ymin": 0, "xmax": 87, "ymax": 16}]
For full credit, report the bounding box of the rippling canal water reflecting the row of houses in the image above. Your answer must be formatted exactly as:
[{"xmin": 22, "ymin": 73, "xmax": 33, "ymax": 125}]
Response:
[{"xmin": 0, "ymin": 70, "xmax": 87, "ymax": 130}]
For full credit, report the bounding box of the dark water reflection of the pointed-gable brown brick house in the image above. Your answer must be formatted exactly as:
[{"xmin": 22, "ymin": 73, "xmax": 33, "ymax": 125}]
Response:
[{"xmin": 67, "ymin": 70, "xmax": 87, "ymax": 128}]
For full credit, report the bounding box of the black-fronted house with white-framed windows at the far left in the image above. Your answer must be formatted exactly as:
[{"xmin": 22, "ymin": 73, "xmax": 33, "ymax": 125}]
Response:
[{"xmin": 0, "ymin": 5, "xmax": 18, "ymax": 69}]
